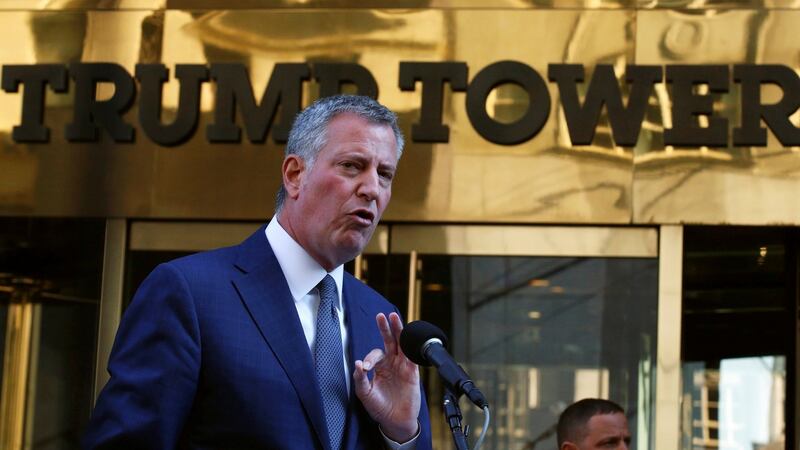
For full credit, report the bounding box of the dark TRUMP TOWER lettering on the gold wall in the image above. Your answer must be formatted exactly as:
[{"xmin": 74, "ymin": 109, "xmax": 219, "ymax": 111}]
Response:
[{"xmin": 2, "ymin": 60, "xmax": 800, "ymax": 147}]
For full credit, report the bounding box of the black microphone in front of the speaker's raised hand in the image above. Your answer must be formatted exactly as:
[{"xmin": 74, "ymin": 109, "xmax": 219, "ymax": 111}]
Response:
[{"xmin": 400, "ymin": 320, "xmax": 489, "ymax": 409}]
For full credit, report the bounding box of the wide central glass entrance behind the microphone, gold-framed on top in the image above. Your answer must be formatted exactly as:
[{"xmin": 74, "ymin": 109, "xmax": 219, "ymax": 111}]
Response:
[{"xmin": 362, "ymin": 225, "xmax": 659, "ymax": 450}]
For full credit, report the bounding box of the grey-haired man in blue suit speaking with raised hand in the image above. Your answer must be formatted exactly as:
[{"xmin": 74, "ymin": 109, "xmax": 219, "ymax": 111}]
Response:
[{"xmin": 84, "ymin": 96, "xmax": 431, "ymax": 450}]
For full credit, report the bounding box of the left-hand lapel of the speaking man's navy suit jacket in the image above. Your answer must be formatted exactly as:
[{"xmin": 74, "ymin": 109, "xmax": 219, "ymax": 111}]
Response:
[{"xmin": 233, "ymin": 227, "xmax": 330, "ymax": 450}]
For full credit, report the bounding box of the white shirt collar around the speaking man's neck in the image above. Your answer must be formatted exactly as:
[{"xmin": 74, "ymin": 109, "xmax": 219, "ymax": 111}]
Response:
[{"xmin": 265, "ymin": 216, "xmax": 344, "ymax": 310}]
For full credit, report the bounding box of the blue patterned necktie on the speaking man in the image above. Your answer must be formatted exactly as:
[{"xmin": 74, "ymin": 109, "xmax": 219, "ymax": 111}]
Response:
[{"xmin": 314, "ymin": 275, "xmax": 347, "ymax": 450}]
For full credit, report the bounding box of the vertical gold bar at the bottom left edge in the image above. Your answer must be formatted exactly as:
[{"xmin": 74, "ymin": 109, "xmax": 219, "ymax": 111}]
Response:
[{"xmin": 0, "ymin": 301, "xmax": 33, "ymax": 450}]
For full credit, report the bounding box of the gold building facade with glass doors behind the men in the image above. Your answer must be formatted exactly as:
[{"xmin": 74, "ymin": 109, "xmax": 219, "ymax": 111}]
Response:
[{"xmin": 0, "ymin": 0, "xmax": 800, "ymax": 450}]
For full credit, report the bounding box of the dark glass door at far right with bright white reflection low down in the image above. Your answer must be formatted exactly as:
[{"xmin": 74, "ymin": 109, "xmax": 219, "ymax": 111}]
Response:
[{"xmin": 680, "ymin": 226, "xmax": 800, "ymax": 450}]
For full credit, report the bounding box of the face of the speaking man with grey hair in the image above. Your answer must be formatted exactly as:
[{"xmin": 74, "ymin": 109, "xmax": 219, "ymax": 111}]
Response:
[{"xmin": 289, "ymin": 113, "xmax": 397, "ymax": 270}]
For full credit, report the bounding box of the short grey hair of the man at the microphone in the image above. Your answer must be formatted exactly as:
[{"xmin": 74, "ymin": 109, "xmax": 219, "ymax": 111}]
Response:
[{"xmin": 275, "ymin": 95, "xmax": 405, "ymax": 215}]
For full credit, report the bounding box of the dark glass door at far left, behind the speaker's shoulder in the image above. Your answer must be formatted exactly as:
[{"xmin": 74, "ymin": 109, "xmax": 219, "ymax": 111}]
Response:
[{"xmin": 0, "ymin": 218, "xmax": 105, "ymax": 450}]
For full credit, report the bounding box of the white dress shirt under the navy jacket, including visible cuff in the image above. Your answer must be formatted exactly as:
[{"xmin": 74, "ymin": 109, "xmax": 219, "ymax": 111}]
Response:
[{"xmin": 265, "ymin": 217, "xmax": 419, "ymax": 450}]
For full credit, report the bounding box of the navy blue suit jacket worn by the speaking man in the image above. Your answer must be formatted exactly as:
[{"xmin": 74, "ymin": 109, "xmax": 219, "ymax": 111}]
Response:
[{"xmin": 83, "ymin": 227, "xmax": 431, "ymax": 450}]
